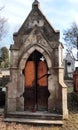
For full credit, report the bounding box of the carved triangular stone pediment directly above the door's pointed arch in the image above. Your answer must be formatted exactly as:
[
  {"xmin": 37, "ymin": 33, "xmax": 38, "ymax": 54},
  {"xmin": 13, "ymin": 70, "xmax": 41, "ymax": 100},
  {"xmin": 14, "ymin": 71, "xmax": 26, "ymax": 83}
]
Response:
[{"xmin": 21, "ymin": 27, "xmax": 52, "ymax": 52}]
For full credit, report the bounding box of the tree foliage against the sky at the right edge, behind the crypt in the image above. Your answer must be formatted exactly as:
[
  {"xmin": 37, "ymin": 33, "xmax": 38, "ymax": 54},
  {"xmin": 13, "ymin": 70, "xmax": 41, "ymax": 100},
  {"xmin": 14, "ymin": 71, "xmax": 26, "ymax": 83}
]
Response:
[{"xmin": 63, "ymin": 23, "xmax": 78, "ymax": 49}]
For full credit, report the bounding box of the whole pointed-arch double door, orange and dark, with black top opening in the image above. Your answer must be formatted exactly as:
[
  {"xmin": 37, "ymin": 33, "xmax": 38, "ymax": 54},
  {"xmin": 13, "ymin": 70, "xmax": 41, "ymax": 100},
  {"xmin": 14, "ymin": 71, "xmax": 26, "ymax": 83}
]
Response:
[{"xmin": 23, "ymin": 51, "xmax": 49, "ymax": 112}]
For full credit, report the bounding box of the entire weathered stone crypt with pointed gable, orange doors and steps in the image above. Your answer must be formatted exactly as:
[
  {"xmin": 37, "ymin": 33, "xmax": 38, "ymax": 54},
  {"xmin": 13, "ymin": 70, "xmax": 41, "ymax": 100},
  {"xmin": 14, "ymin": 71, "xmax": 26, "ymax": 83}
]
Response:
[{"xmin": 4, "ymin": 0, "xmax": 68, "ymax": 124}]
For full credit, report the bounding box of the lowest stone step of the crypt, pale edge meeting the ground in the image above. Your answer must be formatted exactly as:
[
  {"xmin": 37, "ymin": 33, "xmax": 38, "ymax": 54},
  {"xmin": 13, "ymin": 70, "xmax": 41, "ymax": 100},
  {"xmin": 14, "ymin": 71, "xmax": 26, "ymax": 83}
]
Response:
[{"xmin": 3, "ymin": 118, "xmax": 63, "ymax": 125}]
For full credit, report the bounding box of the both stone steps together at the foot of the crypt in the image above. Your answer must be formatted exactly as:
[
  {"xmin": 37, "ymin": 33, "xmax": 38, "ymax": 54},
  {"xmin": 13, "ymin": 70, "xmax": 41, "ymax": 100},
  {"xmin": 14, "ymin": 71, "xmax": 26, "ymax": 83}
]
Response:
[{"xmin": 4, "ymin": 111, "xmax": 63, "ymax": 125}]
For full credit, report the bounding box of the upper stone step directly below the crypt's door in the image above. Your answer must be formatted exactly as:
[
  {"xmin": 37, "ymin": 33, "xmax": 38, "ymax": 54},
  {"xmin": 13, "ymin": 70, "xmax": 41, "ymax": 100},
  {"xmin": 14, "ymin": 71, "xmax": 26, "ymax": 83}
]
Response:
[{"xmin": 7, "ymin": 112, "xmax": 62, "ymax": 120}]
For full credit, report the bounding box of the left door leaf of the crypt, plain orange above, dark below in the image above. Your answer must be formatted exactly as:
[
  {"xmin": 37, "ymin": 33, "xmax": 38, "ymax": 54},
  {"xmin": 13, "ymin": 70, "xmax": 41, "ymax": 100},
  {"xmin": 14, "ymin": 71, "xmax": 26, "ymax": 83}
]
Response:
[{"xmin": 23, "ymin": 61, "xmax": 35, "ymax": 110}]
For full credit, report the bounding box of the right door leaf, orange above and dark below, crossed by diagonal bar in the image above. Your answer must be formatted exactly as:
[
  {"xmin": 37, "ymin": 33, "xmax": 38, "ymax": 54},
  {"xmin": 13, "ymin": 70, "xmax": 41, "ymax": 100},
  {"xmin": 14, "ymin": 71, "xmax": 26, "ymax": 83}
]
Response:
[{"xmin": 37, "ymin": 61, "xmax": 48, "ymax": 111}]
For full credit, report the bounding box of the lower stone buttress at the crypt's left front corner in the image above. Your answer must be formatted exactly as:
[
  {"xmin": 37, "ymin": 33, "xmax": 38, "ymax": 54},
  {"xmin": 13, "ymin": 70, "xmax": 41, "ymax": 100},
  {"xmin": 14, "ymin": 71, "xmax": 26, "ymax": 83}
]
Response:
[{"xmin": 6, "ymin": 68, "xmax": 17, "ymax": 112}]
